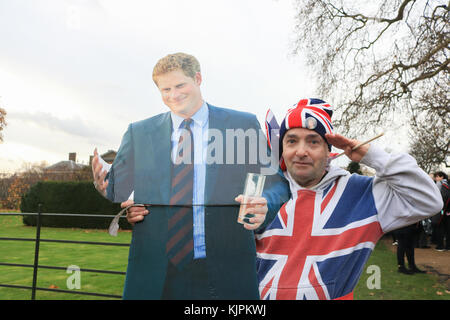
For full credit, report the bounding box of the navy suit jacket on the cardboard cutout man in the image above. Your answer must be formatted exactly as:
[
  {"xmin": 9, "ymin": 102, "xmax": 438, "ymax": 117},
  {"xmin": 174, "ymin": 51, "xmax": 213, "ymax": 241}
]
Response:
[{"xmin": 107, "ymin": 104, "xmax": 289, "ymax": 299}]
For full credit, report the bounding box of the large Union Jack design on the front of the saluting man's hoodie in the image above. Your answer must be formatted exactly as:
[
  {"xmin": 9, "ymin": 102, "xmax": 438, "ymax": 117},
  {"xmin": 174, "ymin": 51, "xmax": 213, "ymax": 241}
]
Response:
[{"xmin": 256, "ymin": 175, "xmax": 382, "ymax": 300}]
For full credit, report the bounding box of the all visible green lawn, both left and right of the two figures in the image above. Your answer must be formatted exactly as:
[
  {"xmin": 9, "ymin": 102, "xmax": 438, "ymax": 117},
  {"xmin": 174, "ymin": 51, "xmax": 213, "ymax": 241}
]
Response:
[{"xmin": 0, "ymin": 212, "xmax": 450, "ymax": 300}]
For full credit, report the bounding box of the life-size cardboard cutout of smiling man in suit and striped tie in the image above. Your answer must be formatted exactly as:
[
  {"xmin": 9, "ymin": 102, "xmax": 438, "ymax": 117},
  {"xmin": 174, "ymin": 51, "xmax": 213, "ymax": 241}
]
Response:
[{"xmin": 93, "ymin": 53, "xmax": 288, "ymax": 299}]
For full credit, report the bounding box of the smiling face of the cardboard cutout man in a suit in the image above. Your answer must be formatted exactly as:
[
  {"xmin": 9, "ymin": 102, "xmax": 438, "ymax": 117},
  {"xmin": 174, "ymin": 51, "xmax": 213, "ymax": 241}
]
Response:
[{"xmin": 156, "ymin": 70, "xmax": 203, "ymax": 118}]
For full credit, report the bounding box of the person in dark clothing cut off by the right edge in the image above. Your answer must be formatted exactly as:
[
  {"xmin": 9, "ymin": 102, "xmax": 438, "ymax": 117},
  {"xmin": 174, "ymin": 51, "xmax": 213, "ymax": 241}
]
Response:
[{"xmin": 433, "ymin": 171, "xmax": 450, "ymax": 251}]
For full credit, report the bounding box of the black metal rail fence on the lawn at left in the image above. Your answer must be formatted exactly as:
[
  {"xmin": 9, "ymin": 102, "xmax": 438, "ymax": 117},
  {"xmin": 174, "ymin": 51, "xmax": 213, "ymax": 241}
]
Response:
[{"xmin": 0, "ymin": 206, "xmax": 129, "ymax": 300}]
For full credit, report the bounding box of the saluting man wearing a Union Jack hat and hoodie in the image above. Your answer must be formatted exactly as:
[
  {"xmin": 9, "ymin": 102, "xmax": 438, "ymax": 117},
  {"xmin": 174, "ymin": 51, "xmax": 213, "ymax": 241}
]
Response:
[{"xmin": 256, "ymin": 99, "xmax": 442, "ymax": 300}]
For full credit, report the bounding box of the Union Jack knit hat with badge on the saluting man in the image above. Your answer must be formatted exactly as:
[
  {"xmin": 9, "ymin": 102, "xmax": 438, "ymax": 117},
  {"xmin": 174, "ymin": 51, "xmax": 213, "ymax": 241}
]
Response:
[{"xmin": 279, "ymin": 99, "xmax": 333, "ymax": 171}]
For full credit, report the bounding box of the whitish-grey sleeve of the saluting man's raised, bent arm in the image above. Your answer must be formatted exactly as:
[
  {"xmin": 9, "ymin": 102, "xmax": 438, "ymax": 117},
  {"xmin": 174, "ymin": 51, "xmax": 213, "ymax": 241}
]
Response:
[{"xmin": 361, "ymin": 145, "xmax": 443, "ymax": 232}]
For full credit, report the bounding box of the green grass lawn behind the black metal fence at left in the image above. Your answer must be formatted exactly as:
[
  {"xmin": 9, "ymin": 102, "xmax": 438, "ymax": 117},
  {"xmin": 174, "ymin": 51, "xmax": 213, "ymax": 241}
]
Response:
[{"xmin": 0, "ymin": 212, "xmax": 131, "ymax": 300}]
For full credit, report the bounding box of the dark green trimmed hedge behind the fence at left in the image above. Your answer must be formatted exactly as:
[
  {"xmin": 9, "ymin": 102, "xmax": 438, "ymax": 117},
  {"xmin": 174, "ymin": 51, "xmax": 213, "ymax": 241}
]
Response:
[{"xmin": 20, "ymin": 181, "xmax": 131, "ymax": 229}]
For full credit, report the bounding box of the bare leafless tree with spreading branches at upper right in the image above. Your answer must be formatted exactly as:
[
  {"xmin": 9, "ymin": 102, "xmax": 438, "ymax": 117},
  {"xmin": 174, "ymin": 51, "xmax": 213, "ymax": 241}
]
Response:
[{"xmin": 294, "ymin": 0, "xmax": 450, "ymax": 162}]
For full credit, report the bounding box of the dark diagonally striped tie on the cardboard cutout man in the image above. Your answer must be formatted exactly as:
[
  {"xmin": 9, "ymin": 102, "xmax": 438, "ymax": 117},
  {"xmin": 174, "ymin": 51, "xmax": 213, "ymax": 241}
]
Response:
[{"xmin": 166, "ymin": 119, "xmax": 194, "ymax": 269}]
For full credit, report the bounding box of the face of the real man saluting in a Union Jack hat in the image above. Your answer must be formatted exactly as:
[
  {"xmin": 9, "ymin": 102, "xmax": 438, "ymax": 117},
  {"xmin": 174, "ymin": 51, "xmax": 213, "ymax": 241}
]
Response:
[{"xmin": 282, "ymin": 128, "xmax": 329, "ymax": 188}]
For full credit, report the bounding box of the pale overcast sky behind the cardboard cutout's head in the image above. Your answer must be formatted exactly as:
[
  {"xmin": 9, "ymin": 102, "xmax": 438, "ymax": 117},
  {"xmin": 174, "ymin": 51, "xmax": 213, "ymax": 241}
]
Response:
[{"xmin": 0, "ymin": 0, "xmax": 404, "ymax": 172}]
